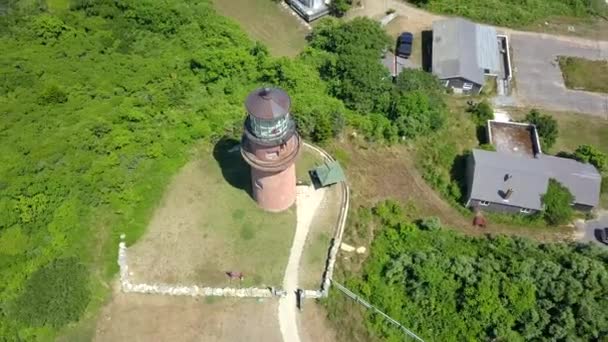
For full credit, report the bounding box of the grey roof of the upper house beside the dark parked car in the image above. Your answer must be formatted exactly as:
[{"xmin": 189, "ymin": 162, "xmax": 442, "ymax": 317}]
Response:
[{"xmin": 432, "ymin": 18, "xmax": 500, "ymax": 85}]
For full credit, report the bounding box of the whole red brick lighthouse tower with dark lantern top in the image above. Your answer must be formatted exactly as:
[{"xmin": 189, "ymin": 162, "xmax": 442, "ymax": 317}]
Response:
[{"xmin": 241, "ymin": 88, "xmax": 302, "ymax": 212}]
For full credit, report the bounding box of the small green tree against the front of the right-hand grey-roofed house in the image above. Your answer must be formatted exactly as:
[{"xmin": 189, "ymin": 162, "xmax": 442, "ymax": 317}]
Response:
[{"xmin": 542, "ymin": 178, "xmax": 574, "ymax": 225}]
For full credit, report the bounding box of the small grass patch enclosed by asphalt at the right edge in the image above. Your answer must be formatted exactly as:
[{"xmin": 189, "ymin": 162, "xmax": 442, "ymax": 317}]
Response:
[{"xmin": 559, "ymin": 56, "xmax": 608, "ymax": 93}]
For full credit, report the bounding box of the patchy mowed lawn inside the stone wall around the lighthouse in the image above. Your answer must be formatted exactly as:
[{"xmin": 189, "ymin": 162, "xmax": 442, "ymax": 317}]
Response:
[{"xmin": 128, "ymin": 141, "xmax": 328, "ymax": 287}]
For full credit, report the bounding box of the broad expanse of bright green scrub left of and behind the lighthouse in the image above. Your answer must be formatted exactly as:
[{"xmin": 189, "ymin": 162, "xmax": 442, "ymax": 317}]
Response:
[{"xmin": 0, "ymin": 0, "xmax": 346, "ymax": 341}]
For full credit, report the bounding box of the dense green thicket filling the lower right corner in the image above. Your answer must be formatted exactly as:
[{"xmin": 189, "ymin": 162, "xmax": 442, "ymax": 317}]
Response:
[{"xmin": 327, "ymin": 201, "xmax": 608, "ymax": 341}]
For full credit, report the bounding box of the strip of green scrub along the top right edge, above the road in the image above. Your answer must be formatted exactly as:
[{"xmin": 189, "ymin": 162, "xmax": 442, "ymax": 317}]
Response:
[{"xmin": 410, "ymin": 0, "xmax": 608, "ymax": 27}]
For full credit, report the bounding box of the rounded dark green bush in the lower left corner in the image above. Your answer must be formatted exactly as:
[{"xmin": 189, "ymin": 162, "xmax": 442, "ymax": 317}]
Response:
[{"xmin": 11, "ymin": 258, "xmax": 90, "ymax": 327}]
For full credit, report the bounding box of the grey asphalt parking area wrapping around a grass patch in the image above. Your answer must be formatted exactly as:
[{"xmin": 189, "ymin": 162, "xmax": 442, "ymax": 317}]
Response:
[{"xmin": 511, "ymin": 33, "xmax": 608, "ymax": 119}]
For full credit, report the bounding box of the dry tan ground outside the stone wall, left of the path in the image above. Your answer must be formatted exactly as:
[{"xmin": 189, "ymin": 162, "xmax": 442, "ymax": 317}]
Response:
[{"xmin": 94, "ymin": 284, "xmax": 282, "ymax": 342}]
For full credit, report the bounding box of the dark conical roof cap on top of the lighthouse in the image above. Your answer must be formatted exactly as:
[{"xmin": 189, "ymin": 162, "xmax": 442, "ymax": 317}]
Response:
[{"xmin": 245, "ymin": 88, "xmax": 291, "ymax": 120}]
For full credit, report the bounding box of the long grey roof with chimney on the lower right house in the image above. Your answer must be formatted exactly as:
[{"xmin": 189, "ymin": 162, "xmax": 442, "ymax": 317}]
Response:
[{"xmin": 471, "ymin": 149, "xmax": 602, "ymax": 210}]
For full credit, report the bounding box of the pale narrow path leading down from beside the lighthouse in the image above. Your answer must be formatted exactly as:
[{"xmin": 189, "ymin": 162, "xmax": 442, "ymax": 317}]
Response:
[{"xmin": 279, "ymin": 186, "xmax": 325, "ymax": 342}]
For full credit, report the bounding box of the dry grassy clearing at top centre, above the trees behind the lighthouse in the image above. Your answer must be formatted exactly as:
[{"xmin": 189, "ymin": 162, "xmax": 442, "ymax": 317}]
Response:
[{"xmin": 213, "ymin": 0, "xmax": 309, "ymax": 57}]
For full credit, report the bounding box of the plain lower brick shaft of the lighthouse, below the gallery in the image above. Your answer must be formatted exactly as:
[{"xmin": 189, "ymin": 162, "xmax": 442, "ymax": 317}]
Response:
[{"xmin": 251, "ymin": 164, "xmax": 296, "ymax": 212}]
